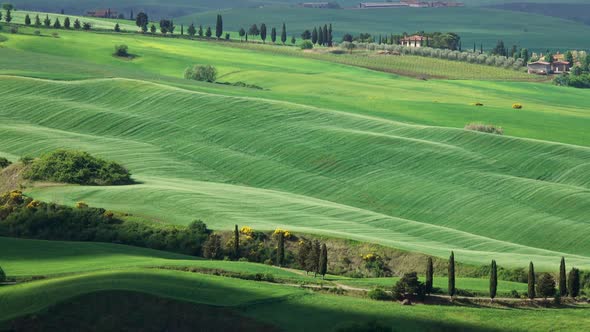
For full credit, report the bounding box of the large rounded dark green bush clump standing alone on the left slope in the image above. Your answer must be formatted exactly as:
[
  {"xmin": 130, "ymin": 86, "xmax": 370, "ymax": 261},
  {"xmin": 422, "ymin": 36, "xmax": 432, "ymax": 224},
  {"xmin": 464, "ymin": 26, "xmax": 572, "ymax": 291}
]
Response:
[{"xmin": 24, "ymin": 150, "xmax": 133, "ymax": 185}]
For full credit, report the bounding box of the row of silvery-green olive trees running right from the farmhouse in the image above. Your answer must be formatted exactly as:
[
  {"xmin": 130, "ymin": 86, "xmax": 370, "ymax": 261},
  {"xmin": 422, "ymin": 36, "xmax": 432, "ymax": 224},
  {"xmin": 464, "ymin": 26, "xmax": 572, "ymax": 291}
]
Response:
[{"xmin": 340, "ymin": 42, "xmax": 525, "ymax": 70}]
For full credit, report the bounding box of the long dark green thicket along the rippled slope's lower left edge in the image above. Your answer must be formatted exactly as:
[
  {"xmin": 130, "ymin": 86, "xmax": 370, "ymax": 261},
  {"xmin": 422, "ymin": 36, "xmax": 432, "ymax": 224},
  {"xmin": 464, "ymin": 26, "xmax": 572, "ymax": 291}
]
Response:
[{"xmin": 0, "ymin": 195, "xmax": 209, "ymax": 256}]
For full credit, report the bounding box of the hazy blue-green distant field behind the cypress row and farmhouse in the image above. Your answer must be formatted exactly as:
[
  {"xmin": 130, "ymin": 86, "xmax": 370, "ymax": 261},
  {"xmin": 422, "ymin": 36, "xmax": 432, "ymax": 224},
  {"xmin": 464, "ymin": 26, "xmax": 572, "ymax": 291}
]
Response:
[{"xmin": 176, "ymin": 6, "xmax": 590, "ymax": 52}]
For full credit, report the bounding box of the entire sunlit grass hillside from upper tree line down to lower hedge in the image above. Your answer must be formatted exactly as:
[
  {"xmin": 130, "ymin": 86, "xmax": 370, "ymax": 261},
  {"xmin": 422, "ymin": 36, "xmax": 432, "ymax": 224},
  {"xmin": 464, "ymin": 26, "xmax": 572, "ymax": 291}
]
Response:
[{"xmin": 0, "ymin": 26, "xmax": 590, "ymax": 270}]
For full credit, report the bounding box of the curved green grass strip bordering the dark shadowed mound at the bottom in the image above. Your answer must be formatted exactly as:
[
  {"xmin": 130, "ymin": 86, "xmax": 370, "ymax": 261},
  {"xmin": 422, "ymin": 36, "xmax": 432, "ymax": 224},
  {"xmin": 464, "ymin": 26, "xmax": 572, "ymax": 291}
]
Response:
[{"xmin": 0, "ymin": 270, "xmax": 590, "ymax": 331}]
